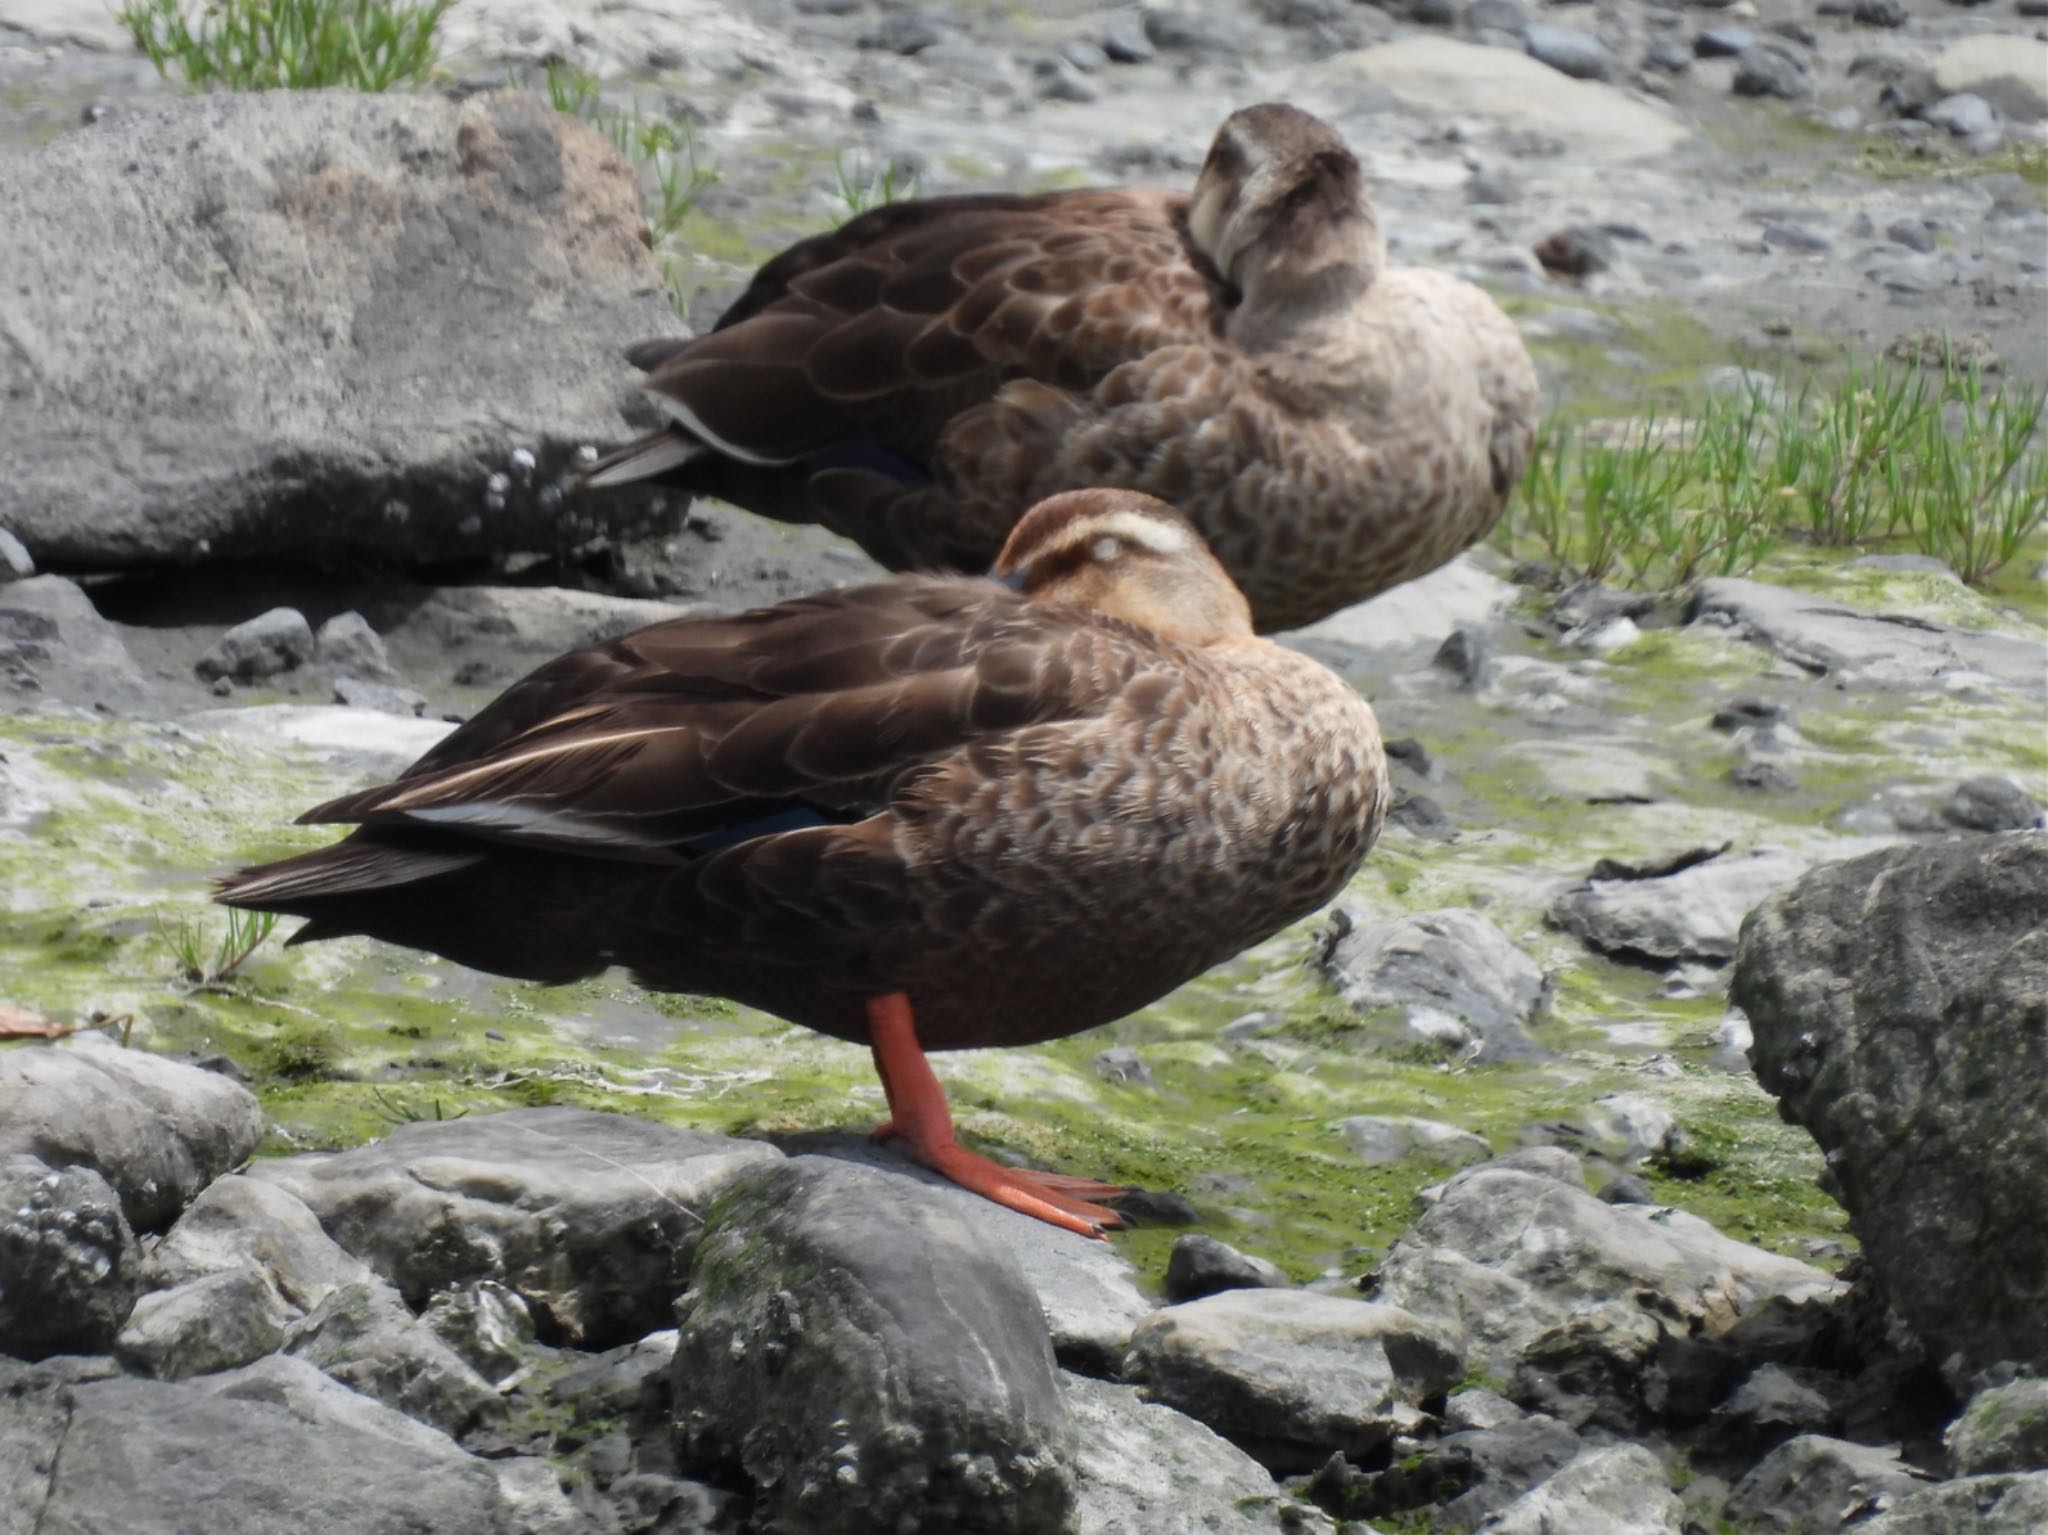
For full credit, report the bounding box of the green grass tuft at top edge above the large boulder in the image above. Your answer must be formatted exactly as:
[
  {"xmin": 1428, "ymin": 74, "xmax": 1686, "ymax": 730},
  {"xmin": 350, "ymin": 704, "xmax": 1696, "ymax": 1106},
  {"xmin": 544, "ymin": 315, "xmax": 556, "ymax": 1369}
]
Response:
[{"xmin": 117, "ymin": 0, "xmax": 455, "ymax": 90}]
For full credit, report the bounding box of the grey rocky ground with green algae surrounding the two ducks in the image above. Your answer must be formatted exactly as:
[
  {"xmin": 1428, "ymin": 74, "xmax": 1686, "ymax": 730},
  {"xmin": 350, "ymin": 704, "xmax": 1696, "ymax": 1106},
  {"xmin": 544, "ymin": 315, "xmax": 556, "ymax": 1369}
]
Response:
[{"xmin": 0, "ymin": 0, "xmax": 2048, "ymax": 1535}]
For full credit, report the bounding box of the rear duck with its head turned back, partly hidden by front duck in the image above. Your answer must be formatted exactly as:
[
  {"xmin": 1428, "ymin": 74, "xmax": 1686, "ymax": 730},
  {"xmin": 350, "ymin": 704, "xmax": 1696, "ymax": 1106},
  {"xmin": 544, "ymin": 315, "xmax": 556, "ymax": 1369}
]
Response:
[{"xmin": 586, "ymin": 104, "xmax": 1538, "ymax": 632}]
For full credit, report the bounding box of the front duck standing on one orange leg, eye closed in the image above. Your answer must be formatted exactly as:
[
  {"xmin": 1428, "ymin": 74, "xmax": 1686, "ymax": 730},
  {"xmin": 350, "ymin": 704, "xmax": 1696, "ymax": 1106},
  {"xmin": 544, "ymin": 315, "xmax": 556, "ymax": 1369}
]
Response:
[{"xmin": 217, "ymin": 491, "xmax": 1386, "ymax": 1236}]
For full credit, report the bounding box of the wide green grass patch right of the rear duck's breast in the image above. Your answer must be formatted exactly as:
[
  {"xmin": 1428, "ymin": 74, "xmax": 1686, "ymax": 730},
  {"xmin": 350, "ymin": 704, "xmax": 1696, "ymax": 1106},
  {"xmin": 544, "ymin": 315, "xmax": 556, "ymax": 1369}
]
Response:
[{"xmin": 1495, "ymin": 352, "xmax": 2048, "ymax": 589}]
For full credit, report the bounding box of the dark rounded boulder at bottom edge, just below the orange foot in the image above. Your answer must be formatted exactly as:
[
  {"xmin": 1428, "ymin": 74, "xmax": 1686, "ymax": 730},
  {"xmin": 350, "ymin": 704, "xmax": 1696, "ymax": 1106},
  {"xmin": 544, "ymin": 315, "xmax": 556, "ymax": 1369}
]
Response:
[{"xmin": 674, "ymin": 1156, "xmax": 1073, "ymax": 1535}]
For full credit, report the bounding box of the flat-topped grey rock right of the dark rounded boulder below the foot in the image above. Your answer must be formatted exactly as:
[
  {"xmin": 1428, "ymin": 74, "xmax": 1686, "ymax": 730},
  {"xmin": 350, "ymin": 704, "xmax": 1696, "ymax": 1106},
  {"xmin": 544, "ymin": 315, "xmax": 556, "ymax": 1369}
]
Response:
[{"xmin": 1122, "ymin": 1289, "xmax": 1464, "ymax": 1472}]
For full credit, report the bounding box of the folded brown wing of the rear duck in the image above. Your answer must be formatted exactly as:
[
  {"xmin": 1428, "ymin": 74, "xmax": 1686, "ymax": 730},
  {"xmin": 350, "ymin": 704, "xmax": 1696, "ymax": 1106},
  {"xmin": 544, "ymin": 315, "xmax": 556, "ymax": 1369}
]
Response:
[{"xmin": 633, "ymin": 188, "xmax": 1229, "ymax": 463}]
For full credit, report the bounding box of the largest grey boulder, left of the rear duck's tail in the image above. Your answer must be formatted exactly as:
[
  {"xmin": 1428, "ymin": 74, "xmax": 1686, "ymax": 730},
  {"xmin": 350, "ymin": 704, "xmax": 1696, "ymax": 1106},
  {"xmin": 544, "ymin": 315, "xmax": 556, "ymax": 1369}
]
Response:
[{"xmin": 0, "ymin": 90, "xmax": 678, "ymax": 569}]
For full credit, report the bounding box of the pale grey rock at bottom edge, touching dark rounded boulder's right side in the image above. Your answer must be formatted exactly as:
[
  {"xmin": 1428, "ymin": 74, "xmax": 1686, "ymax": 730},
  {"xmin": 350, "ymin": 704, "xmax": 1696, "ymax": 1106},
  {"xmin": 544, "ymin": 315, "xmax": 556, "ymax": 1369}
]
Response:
[{"xmin": 1059, "ymin": 1371, "xmax": 1329, "ymax": 1535}]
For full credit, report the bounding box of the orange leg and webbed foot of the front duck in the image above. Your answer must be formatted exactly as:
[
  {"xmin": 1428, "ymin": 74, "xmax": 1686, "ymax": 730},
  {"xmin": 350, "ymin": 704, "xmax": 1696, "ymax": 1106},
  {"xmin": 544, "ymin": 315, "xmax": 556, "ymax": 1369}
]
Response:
[{"xmin": 868, "ymin": 991, "xmax": 1124, "ymax": 1236}]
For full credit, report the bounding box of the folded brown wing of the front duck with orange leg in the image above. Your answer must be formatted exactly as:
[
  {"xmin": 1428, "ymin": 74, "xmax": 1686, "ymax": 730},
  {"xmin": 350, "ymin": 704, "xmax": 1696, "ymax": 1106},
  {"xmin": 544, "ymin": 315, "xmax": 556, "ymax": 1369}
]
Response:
[{"xmin": 301, "ymin": 581, "xmax": 1143, "ymax": 862}]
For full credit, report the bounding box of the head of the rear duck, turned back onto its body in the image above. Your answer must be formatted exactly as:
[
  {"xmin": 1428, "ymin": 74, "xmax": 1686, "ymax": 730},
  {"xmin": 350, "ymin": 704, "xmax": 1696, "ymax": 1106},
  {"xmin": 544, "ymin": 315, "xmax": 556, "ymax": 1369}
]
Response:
[{"xmin": 1188, "ymin": 102, "xmax": 1386, "ymax": 307}]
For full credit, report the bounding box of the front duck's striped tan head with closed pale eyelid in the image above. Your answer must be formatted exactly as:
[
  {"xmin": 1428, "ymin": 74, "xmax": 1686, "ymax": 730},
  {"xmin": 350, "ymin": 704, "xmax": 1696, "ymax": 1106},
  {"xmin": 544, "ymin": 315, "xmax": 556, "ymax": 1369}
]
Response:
[{"xmin": 989, "ymin": 491, "xmax": 1251, "ymax": 645}]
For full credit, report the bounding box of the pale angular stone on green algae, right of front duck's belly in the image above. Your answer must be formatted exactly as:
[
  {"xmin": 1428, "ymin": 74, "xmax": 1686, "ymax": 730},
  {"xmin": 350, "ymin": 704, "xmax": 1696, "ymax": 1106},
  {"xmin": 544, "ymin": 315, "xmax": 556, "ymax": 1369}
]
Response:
[{"xmin": 1317, "ymin": 907, "xmax": 1550, "ymax": 1058}]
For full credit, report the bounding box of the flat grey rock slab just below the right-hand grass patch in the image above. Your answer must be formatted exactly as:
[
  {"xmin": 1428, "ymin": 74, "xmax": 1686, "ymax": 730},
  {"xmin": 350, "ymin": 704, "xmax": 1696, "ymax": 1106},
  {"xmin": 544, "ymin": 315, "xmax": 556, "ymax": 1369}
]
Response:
[{"xmin": 1690, "ymin": 577, "xmax": 2048, "ymax": 700}]
